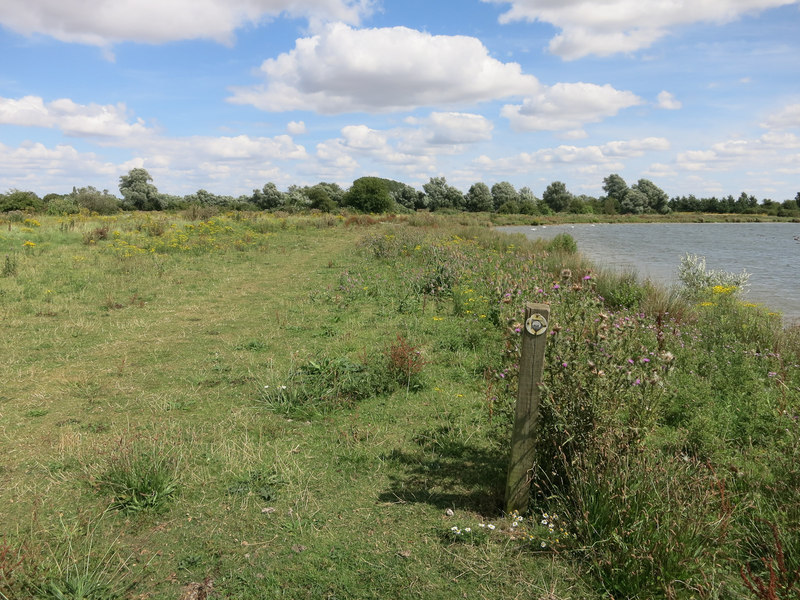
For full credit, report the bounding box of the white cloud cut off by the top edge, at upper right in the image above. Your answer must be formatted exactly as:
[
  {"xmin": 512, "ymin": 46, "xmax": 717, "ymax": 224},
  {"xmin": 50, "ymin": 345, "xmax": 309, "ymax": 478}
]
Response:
[{"xmin": 483, "ymin": 0, "xmax": 800, "ymax": 60}]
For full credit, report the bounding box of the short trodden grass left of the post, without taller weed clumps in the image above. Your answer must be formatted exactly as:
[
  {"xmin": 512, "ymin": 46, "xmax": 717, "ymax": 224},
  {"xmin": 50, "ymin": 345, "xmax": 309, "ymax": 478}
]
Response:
[{"xmin": 0, "ymin": 219, "xmax": 585, "ymax": 599}]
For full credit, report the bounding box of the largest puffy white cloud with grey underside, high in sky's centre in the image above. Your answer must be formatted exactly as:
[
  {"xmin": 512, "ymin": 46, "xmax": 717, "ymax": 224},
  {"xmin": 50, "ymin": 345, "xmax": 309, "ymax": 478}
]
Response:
[{"xmin": 230, "ymin": 23, "xmax": 539, "ymax": 114}]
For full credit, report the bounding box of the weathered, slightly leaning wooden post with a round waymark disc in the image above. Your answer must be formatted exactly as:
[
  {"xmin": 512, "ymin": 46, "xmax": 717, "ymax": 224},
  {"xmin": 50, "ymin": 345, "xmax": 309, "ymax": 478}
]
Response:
[{"xmin": 506, "ymin": 303, "xmax": 550, "ymax": 514}]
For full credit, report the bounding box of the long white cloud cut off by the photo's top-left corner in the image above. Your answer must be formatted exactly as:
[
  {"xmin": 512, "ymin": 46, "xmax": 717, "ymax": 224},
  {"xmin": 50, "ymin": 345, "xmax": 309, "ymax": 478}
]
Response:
[{"xmin": 0, "ymin": 0, "xmax": 372, "ymax": 46}]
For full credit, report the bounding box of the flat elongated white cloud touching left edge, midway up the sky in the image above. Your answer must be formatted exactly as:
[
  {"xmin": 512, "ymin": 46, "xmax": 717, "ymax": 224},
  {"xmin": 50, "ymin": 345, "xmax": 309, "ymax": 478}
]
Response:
[{"xmin": 0, "ymin": 96, "xmax": 153, "ymax": 138}]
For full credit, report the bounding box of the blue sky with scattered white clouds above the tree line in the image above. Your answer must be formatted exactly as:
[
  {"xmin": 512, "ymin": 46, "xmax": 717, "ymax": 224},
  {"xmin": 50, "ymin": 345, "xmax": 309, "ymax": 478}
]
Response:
[{"xmin": 0, "ymin": 0, "xmax": 800, "ymax": 201}]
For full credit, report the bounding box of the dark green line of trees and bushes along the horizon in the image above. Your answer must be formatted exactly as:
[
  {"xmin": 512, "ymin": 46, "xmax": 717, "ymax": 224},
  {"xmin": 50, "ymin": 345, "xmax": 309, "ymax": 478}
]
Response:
[{"xmin": 0, "ymin": 168, "xmax": 800, "ymax": 217}]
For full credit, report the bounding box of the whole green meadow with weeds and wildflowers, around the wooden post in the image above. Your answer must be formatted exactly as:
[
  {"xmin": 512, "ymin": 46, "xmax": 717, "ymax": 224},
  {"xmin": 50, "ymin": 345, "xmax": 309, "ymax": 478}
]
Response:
[{"xmin": 0, "ymin": 211, "xmax": 800, "ymax": 600}]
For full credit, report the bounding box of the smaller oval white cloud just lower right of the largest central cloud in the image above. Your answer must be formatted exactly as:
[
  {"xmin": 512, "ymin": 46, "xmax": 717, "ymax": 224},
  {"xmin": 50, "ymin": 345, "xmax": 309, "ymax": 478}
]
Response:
[{"xmin": 500, "ymin": 83, "xmax": 642, "ymax": 131}]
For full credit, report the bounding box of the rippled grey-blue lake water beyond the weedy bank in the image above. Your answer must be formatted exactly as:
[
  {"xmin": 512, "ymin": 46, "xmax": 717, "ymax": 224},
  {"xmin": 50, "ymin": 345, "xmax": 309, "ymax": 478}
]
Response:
[{"xmin": 500, "ymin": 223, "xmax": 800, "ymax": 321}]
